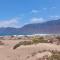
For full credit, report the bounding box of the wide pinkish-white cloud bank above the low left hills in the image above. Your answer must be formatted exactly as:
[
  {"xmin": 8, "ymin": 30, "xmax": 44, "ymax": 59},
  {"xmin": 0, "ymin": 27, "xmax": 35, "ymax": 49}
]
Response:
[{"xmin": 0, "ymin": 18, "xmax": 19, "ymax": 27}]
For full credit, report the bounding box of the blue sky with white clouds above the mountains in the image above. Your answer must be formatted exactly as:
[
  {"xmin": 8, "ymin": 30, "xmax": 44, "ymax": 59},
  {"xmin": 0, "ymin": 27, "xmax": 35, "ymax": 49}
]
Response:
[{"xmin": 0, "ymin": 0, "xmax": 60, "ymax": 28}]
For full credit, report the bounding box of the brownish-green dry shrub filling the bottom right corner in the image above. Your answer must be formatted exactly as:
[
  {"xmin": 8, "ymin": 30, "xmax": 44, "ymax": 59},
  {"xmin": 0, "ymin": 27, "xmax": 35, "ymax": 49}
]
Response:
[{"xmin": 37, "ymin": 52, "xmax": 60, "ymax": 60}]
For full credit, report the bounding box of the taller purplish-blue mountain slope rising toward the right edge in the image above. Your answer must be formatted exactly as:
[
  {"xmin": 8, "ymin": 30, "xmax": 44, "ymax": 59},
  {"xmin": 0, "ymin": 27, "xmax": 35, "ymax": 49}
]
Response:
[{"xmin": 21, "ymin": 19, "xmax": 60, "ymax": 34}]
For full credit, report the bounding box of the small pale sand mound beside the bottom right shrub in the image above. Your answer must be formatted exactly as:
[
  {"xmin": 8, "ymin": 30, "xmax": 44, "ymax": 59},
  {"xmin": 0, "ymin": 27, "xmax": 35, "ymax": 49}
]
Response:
[{"xmin": 27, "ymin": 52, "xmax": 52, "ymax": 60}]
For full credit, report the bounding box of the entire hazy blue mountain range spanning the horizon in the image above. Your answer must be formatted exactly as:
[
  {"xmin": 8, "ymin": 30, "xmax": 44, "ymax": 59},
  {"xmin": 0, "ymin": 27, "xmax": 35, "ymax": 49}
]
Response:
[{"xmin": 0, "ymin": 19, "xmax": 60, "ymax": 35}]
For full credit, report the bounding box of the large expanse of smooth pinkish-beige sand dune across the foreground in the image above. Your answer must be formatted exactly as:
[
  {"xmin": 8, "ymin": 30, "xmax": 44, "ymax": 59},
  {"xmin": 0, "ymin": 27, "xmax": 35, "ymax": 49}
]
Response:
[{"xmin": 0, "ymin": 41, "xmax": 60, "ymax": 60}]
